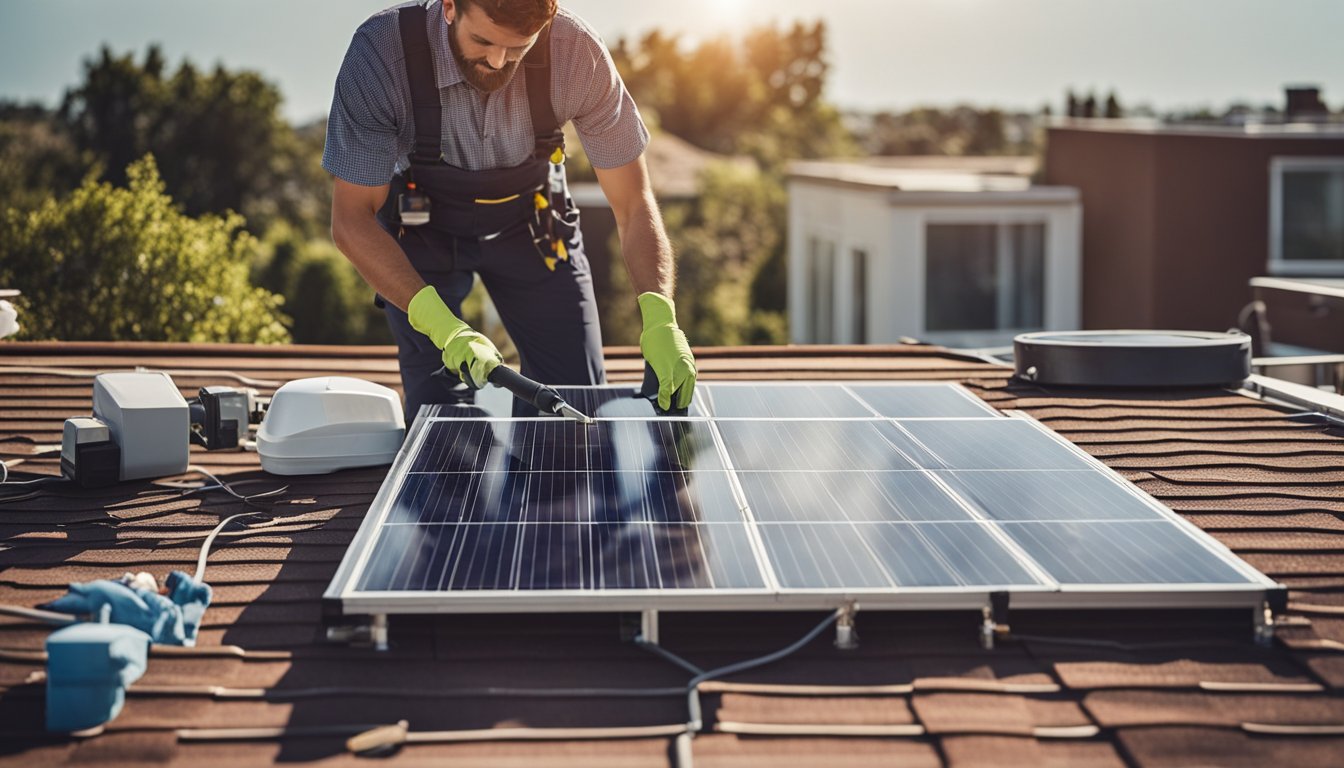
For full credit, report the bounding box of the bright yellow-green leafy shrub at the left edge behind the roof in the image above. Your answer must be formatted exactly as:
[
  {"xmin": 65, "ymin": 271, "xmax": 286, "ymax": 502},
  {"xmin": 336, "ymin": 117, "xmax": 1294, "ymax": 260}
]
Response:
[{"xmin": 0, "ymin": 156, "xmax": 289, "ymax": 343}]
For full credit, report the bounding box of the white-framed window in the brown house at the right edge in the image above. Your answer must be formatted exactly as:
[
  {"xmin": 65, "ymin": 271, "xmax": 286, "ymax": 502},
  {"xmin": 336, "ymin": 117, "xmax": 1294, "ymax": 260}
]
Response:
[{"xmin": 1270, "ymin": 157, "xmax": 1344, "ymax": 274}]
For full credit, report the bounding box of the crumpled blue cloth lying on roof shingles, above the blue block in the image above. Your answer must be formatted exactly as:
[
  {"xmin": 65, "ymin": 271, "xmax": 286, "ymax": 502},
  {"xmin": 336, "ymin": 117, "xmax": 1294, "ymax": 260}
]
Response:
[{"xmin": 42, "ymin": 570, "xmax": 211, "ymax": 646}]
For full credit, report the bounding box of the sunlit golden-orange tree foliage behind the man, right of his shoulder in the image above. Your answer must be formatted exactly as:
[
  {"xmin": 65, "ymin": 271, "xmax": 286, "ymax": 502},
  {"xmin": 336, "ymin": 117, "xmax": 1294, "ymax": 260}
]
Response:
[{"xmin": 612, "ymin": 22, "xmax": 853, "ymax": 169}]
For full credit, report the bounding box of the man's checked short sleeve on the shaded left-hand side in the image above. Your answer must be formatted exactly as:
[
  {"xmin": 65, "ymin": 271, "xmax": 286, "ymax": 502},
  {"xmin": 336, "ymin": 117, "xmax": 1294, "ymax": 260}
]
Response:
[{"xmin": 323, "ymin": 24, "xmax": 405, "ymax": 187}]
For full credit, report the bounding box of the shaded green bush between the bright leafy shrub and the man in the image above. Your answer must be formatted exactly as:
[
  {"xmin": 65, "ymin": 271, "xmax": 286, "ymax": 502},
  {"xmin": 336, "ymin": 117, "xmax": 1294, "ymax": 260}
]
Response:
[{"xmin": 253, "ymin": 223, "xmax": 392, "ymax": 344}]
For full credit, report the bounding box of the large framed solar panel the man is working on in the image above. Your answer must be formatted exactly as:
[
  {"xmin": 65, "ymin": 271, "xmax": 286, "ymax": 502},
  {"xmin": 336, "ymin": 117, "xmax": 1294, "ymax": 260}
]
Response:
[{"xmin": 328, "ymin": 382, "xmax": 1274, "ymax": 613}]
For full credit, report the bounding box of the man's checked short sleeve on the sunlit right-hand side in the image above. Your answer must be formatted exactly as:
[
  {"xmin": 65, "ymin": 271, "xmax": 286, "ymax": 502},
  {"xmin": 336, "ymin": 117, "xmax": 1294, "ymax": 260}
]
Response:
[{"xmin": 552, "ymin": 19, "xmax": 649, "ymax": 168}]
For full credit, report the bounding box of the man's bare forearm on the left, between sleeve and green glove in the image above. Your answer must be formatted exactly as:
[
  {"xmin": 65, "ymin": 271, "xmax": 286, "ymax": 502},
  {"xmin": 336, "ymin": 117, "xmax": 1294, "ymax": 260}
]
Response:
[{"xmin": 332, "ymin": 178, "xmax": 425, "ymax": 312}]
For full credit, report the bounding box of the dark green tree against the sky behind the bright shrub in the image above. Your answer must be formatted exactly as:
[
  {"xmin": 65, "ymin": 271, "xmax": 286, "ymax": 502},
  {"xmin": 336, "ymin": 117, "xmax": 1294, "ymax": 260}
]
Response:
[{"xmin": 60, "ymin": 46, "xmax": 331, "ymax": 234}]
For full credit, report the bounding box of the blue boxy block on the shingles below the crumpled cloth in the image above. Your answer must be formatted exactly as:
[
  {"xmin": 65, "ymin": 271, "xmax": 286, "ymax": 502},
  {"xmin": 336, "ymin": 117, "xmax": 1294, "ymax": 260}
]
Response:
[{"xmin": 47, "ymin": 624, "xmax": 149, "ymax": 732}]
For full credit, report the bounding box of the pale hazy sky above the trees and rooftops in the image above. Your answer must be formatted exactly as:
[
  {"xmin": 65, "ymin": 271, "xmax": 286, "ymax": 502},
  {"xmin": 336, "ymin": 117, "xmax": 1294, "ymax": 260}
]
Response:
[{"xmin": 0, "ymin": 0, "xmax": 1344, "ymax": 122}]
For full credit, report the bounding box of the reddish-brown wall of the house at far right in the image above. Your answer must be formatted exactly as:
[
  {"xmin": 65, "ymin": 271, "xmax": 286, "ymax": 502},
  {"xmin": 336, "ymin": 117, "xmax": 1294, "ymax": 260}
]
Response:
[{"xmin": 1046, "ymin": 126, "xmax": 1344, "ymax": 331}]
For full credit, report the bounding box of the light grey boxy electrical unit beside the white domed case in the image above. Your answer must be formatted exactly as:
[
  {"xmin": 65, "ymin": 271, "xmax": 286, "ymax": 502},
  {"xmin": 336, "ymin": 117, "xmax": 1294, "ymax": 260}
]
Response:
[{"xmin": 93, "ymin": 373, "xmax": 191, "ymax": 480}]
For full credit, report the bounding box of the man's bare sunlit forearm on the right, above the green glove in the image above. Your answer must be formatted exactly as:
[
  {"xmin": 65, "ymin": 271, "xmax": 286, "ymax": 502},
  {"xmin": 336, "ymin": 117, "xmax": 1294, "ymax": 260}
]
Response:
[{"xmin": 594, "ymin": 155, "xmax": 676, "ymax": 299}]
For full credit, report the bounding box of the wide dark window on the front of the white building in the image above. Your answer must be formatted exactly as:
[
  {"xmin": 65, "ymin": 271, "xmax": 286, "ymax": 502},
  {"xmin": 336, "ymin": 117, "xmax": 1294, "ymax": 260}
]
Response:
[{"xmin": 925, "ymin": 223, "xmax": 1046, "ymax": 331}]
